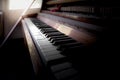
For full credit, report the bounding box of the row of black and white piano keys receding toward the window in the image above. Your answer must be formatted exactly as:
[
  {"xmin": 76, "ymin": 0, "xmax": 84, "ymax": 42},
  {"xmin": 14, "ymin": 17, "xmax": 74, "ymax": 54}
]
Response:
[{"xmin": 24, "ymin": 18, "xmax": 85, "ymax": 80}]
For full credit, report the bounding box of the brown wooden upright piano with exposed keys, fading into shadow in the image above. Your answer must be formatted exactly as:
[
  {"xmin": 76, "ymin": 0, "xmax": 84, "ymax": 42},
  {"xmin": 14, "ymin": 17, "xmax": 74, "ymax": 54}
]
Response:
[{"xmin": 21, "ymin": 0, "xmax": 116, "ymax": 80}]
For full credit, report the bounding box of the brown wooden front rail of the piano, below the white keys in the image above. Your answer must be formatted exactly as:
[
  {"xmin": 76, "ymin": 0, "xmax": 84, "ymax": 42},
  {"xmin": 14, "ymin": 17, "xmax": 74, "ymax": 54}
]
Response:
[{"xmin": 22, "ymin": 20, "xmax": 41, "ymax": 75}]
